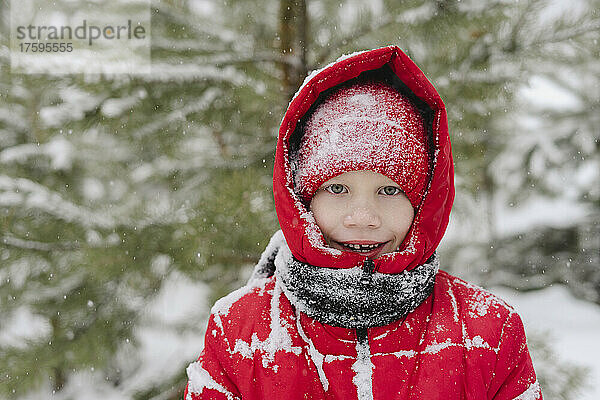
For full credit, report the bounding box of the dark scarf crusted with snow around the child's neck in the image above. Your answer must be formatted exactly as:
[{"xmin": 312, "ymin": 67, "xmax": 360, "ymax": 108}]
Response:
[{"xmin": 251, "ymin": 234, "xmax": 439, "ymax": 329}]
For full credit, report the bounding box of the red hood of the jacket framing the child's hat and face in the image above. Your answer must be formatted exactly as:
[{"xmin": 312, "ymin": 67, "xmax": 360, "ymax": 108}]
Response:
[{"xmin": 273, "ymin": 46, "xmax": 454, "ymax": 273}]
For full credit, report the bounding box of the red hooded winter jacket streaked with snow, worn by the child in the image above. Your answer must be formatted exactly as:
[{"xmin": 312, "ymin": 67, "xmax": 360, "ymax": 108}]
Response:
[{"xmin": 185, "ymin": 46, "xmax": 542, "ymax": 400}]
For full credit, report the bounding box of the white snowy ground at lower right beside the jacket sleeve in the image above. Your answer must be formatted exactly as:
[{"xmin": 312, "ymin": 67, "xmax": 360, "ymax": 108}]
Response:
[{"xmin": 492, "ymin": 285, "xmax": 600, "ymax": 400}]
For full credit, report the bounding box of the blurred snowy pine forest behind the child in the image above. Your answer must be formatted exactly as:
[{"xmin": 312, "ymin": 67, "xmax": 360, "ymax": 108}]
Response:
[{"xmin": 0, "ymin": 0, "xmax": 600, "ymax": 400}]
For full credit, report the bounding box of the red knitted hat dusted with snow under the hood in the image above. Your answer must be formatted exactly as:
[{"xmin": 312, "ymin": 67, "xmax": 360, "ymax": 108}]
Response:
[{"xmin": 292, "ymin": 82, "xmax": 428, "ymax": 209}]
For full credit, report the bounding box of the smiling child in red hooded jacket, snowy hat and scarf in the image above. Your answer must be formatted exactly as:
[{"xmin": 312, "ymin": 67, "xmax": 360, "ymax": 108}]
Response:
[{"xmin": 186, "ymin": 46, "xmax": 542, "ymax": 400}]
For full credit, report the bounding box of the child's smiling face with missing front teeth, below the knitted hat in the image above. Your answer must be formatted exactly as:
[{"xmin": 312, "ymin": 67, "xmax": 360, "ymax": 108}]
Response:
[{"xmin": 310, "ymin": 171, "xmax": 414, "ymax": 259}]
